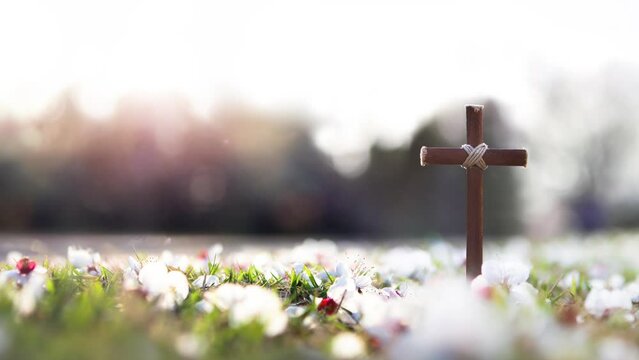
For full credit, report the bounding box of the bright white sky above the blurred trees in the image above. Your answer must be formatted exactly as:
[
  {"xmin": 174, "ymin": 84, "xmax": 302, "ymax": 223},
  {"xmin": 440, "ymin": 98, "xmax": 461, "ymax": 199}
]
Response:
[{"xmin": 0, "ymin": 0, "xmax": 639, "ymax": 160}]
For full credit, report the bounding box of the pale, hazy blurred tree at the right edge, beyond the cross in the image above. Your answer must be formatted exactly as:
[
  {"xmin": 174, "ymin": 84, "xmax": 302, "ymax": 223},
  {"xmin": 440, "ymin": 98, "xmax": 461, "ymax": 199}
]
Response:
[{"xmin": 532, "ymin": 66, "xmax": 639, "ymax": 231}]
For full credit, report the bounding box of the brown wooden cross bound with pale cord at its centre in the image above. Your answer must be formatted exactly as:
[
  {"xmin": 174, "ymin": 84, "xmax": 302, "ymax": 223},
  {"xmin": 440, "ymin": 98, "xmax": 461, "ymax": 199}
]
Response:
[{"xmin": 420, "ymin": 105, "xmax": 528, "ymax": 279}]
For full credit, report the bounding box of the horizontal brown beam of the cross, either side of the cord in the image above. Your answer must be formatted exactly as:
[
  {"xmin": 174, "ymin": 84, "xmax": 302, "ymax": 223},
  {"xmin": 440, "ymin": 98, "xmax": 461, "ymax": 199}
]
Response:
[{"xmin": 420, "ymin": 146, "xmax": 528, "ymax": 167}]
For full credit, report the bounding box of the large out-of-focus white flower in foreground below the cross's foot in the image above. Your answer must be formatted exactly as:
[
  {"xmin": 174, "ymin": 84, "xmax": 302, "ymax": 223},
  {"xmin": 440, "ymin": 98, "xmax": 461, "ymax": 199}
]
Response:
[{"xmin": 390, "ymin": 278, "xmax": 513, "ymax": 359}]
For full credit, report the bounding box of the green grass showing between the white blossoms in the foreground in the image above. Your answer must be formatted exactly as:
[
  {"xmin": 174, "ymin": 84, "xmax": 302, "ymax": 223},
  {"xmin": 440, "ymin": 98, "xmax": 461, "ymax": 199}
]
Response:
[{"xmin": 0, "ymin": 235, "xmax": 639, "ymax": 360}]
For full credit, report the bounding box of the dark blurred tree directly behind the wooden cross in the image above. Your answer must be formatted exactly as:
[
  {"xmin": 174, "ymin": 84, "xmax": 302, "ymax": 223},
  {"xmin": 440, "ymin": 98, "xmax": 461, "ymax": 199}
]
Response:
[{"xmin": 353, "ymin": 102, "xmax": 521, "ymax": 236}]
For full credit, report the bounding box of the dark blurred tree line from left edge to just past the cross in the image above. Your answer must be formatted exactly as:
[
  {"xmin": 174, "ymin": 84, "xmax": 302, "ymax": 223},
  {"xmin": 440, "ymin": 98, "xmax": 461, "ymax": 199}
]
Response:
[{"xmin": 0, "ymin": 96, "xmax": 521, "ymax": 236}]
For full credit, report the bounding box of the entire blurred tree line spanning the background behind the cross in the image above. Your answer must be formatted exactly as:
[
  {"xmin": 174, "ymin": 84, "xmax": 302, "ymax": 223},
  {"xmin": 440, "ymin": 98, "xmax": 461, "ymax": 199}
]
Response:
[{"xmin": 0, "ymin": 68, "xmax": 639, "ymax": 237}]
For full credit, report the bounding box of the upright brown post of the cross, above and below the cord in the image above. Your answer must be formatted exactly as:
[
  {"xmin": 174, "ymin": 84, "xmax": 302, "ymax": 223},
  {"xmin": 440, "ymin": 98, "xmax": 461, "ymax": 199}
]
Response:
[{"xmin": 466, "ymin": 105, "xmax": 484, "ymax": 278}]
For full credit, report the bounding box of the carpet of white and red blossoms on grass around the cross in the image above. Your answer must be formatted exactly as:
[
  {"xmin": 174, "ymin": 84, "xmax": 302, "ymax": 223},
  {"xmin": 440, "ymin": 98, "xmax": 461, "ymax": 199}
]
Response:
[{"xmin": 0, "ymin": 235, "xmax": 639, "ymax": 359}]
